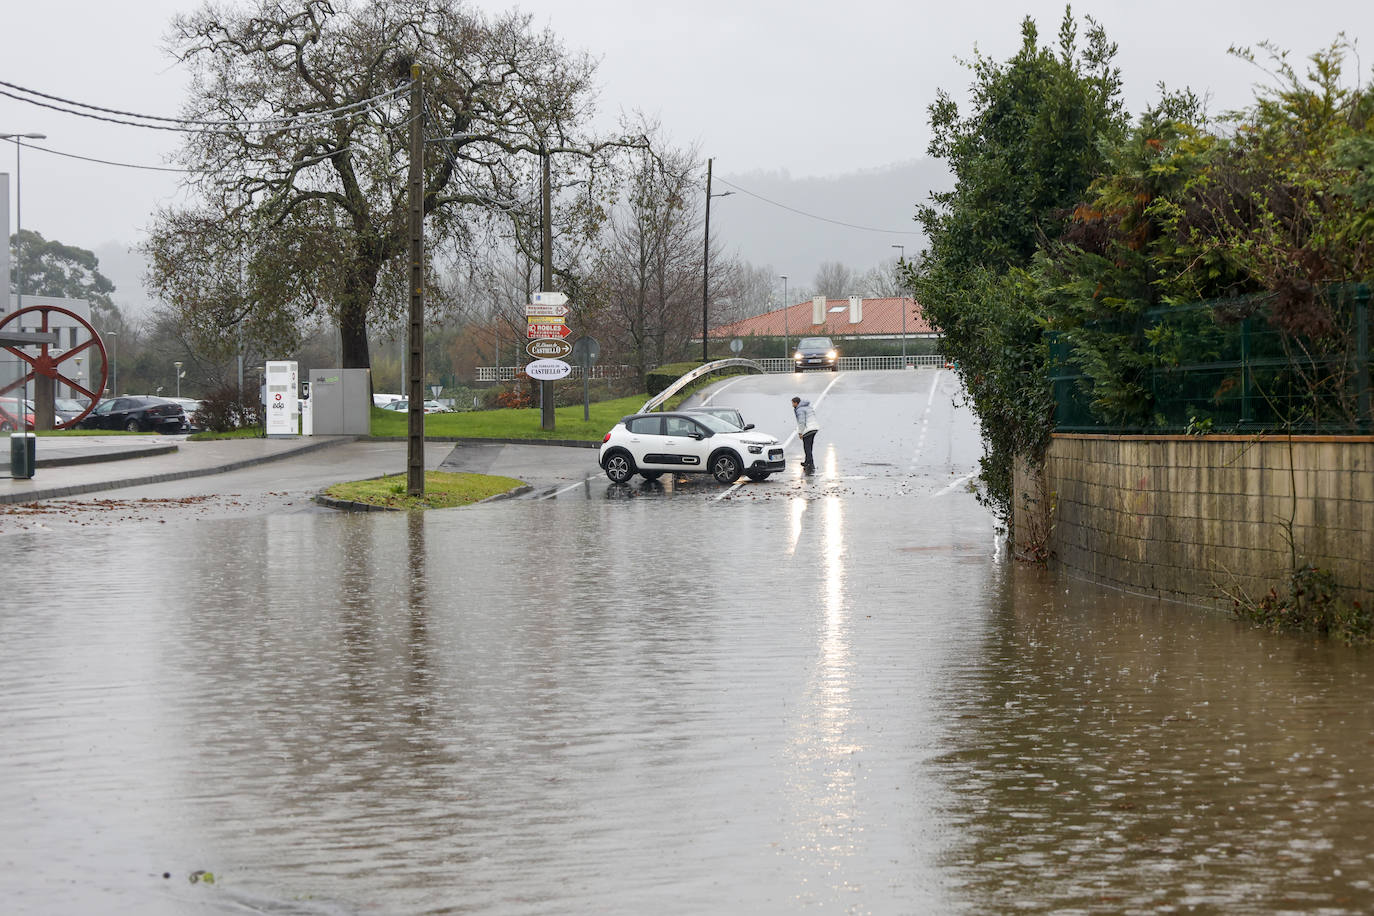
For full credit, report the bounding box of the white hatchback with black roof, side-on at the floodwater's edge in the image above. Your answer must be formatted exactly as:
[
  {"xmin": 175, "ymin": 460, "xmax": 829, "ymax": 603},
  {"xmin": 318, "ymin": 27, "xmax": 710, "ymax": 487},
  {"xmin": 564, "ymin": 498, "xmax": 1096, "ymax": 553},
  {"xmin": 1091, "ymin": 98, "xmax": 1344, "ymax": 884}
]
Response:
[{"xmin": 599, "ymin": 413, "xmax": 786, "ymax": 483}]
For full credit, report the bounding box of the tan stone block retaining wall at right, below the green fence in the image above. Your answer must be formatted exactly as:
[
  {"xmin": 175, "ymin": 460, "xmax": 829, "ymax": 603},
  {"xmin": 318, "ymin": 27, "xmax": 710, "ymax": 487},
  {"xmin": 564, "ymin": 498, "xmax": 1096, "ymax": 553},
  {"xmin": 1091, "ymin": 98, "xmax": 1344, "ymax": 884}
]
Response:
[{"xmin": 1015, "ymin": 434, "xmax": 1374, "ymax": 606}]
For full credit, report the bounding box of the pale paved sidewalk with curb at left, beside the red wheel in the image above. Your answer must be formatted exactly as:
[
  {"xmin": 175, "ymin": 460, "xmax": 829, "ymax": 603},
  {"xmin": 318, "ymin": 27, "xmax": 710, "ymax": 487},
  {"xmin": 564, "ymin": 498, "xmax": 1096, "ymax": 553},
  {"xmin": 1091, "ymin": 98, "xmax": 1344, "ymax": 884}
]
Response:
[{"xmin": 0, "ymin": 435, "xmax": 356, "ymax": 504}]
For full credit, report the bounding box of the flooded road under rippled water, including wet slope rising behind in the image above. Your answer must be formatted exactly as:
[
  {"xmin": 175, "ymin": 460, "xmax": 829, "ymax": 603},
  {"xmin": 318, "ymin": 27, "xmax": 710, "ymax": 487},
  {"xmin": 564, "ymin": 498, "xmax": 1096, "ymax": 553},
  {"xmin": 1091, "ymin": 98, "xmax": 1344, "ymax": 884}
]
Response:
[{"xmin": 0, "ymin": 372, "xmax": 1374, "ymax": 913}]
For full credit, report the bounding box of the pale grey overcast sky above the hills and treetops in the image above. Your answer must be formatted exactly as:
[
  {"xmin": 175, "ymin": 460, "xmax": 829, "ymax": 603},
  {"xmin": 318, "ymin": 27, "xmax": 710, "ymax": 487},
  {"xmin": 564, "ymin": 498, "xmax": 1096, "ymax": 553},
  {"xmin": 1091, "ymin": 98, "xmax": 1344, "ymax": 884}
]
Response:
[{"xmin": 0, "ymin": 0, "xmax": 1374, "ymax": 289}]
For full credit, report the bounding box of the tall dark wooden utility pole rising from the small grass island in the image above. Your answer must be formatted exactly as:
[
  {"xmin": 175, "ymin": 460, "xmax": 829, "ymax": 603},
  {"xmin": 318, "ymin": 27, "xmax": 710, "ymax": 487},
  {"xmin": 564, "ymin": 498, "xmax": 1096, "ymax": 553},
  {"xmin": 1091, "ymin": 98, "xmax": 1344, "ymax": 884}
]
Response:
[{"xmin": 405, "ymin": 63, "xmax": 425, "ymax": 496}]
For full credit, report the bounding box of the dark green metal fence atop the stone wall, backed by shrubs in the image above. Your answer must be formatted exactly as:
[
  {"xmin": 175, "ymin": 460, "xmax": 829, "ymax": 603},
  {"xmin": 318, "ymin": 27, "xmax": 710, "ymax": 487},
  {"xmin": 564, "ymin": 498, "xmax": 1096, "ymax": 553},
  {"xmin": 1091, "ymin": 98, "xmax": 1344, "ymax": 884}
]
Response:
[{"xmin": 1048, "ymin": 284, "xmax": 1374, "ymax": 434}]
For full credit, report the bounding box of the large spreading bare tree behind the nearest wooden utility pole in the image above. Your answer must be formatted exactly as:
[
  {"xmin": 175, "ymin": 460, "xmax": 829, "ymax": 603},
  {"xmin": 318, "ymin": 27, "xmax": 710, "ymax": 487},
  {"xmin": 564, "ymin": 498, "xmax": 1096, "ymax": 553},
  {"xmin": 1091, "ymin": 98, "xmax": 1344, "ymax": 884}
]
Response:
[{"xmin": 146, "ymin": 0, "xmax": 638, "ymax": 367}]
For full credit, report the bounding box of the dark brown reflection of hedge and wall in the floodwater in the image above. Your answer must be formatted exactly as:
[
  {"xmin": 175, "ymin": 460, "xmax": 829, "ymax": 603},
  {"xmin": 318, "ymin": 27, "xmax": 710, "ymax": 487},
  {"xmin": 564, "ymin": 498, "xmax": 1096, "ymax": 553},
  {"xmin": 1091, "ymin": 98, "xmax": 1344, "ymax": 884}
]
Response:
[{"xmin": 937, "ymin": 569, "xmax": 1374, "ymax": 913}]
